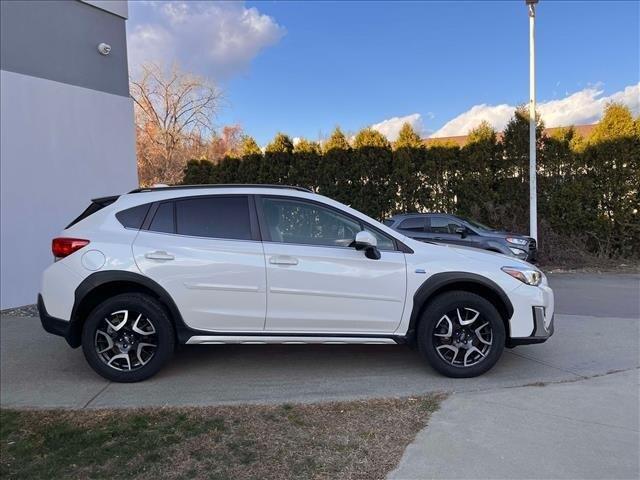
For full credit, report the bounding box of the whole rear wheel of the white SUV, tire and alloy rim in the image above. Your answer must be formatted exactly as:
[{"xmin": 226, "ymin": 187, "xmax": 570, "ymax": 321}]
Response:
[{"xmin": 82, "ymin": 293, "xmax": 175, "ymax": 382}]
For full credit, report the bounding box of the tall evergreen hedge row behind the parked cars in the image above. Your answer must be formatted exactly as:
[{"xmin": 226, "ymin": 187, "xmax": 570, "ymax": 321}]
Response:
[{"xmin": 184, "ymin": 104, "xmax": 640, "ymax": 263}]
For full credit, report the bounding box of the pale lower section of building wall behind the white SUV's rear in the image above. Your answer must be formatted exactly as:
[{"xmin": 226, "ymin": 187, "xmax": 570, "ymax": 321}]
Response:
[{"xmin": 0, "ymin": 70, "xmax": 138, "ymax": 309}]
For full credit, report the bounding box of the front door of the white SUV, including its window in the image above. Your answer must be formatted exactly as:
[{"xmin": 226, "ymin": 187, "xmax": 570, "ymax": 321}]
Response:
[{"xmin": 258, "ymin": 197, "xmax": 406, "ymax": 334}]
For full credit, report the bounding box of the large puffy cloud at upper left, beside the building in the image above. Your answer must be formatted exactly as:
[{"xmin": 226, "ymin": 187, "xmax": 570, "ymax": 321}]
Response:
[{"xmin": 128, "ymin": 2, "xmax": 285, "ymax": 79}]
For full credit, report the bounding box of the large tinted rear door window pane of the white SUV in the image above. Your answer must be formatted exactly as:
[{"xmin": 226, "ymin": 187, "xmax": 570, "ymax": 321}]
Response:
[{"xmin": 175, "ymin": 196, "xmax": 251, "ymax": 240}]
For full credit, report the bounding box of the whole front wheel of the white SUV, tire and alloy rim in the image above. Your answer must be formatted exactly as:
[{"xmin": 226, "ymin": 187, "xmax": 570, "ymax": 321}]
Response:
[{"xmin": 417, "ymin": 291, "xmax": 506, "ymax": 378}]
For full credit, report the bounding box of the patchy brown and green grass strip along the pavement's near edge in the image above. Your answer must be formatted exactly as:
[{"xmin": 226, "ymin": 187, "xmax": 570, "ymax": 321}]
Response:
[{"xmin": 0, "ymin": 394, "xmax": 444, "ymax": 479}]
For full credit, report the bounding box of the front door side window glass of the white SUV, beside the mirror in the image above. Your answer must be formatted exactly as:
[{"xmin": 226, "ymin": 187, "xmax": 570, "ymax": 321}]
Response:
[{"xmin": 262, "ymin": 198, "xmax": 394, "ymax": 250}]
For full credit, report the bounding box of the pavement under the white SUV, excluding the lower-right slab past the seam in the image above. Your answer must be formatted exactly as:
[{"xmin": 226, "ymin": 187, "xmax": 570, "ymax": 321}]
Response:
[{"xmin": 0, "ymin": 275, "xmax": 640, "ymax": 408}]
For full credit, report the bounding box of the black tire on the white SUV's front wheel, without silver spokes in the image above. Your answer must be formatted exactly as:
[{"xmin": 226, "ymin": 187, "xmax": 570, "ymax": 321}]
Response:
[{"xmin": 417, "ymin": 291, "xmax": 506, "ymax": 378}]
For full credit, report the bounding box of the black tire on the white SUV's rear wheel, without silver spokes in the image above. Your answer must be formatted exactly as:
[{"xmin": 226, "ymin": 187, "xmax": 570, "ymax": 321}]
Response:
[{"xmin": 82, "ymin": 293, "xmax": 175, "ymax": 383}]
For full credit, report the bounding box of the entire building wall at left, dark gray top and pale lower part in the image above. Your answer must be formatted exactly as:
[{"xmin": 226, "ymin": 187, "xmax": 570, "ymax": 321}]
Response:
[{"xmin": 0, "ymin": 0, "xmax": 138, "ymax": 309}]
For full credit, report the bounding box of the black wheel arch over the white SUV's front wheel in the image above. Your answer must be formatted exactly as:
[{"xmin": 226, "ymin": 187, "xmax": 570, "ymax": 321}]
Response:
[{"xmin": 407, "ymin": 272, "xmax": 513, "ymax": 338}]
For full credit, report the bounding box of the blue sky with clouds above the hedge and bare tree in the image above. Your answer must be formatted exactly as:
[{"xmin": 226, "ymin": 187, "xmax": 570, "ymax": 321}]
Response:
[{"xmin": 128, "ymin": 0, "xmax": 640, "ymax": 145}]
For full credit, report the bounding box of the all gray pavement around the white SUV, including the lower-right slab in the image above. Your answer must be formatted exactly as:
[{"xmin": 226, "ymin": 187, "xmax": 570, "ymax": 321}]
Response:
[{"xmin": 0, "ymin": 274, "xmax": 640, "ymax": 479}]
